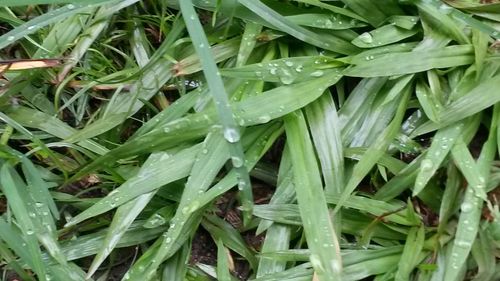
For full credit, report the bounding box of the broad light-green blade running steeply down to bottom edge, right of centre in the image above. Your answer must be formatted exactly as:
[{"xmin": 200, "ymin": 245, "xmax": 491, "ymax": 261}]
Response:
[{"xmin": 285, "ymin": 112, "xmax": 342, "ymax": 280}]
